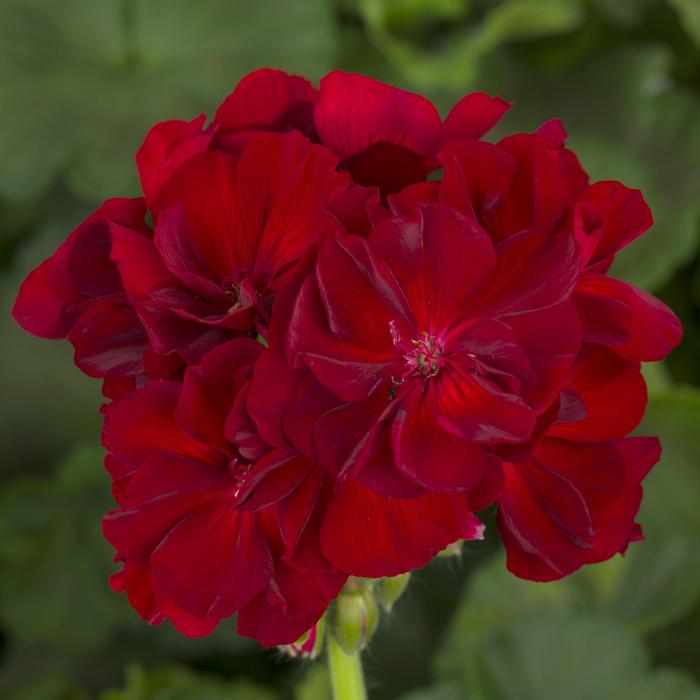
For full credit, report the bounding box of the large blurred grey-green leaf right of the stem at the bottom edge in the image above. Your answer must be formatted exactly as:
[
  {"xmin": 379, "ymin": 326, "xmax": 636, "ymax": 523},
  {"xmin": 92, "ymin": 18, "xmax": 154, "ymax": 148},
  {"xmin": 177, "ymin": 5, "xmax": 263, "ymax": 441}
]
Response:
[{"xmin": 436, "ymin": 557, "xmax": 697, "ymax": 700}]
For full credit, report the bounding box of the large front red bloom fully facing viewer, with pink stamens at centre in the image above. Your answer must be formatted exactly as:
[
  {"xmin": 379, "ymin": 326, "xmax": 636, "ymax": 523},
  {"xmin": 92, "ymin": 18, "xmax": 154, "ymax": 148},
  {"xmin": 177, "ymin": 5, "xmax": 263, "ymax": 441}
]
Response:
[{"xmin": 273, "ymin": 203, "xmax": 580, "ymax": 497}]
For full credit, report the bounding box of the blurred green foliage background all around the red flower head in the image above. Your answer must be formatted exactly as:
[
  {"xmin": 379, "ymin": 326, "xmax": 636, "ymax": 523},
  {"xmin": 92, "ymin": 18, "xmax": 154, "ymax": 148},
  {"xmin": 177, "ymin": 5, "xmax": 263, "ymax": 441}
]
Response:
[{"xmin": 0, "ymin": 0, "xmax": 700, "ymax": 700}]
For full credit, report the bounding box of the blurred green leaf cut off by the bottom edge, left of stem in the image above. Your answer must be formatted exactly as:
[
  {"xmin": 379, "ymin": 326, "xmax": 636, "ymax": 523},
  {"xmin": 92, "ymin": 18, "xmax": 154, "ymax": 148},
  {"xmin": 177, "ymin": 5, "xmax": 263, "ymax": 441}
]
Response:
[{"xmin": 100, "ymin": 666, "xmax": 275, "ymax": 700}]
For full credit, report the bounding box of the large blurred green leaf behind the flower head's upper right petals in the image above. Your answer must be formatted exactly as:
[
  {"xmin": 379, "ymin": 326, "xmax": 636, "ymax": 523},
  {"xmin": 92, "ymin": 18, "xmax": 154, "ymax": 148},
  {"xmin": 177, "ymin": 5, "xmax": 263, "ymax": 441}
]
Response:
[{"xmin": 479, "ymin": 46, "xmax": 700, "ymax": 289}]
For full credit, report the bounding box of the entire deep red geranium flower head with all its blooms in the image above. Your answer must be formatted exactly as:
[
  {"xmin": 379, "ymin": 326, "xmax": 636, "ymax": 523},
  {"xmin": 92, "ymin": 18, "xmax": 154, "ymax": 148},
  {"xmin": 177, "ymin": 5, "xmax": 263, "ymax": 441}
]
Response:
[{"xmin": 14, "ymin": 70, "xmax": 681, "ymax": 646}]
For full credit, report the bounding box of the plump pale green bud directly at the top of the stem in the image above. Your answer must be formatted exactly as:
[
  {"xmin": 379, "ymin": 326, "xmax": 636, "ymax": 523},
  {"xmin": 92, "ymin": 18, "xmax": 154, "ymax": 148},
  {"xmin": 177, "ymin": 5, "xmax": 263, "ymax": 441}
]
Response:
[{"xmin": 333, "ymin": 584, "xmax": 379, "ymax": 654}]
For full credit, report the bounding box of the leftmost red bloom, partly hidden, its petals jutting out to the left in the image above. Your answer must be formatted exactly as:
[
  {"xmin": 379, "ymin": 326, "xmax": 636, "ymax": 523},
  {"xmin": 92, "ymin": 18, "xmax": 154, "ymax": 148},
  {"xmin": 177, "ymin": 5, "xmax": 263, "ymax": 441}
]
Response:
[{"xmin": 12, "ymin": 199, "xmax": 180, "ymax": 395}]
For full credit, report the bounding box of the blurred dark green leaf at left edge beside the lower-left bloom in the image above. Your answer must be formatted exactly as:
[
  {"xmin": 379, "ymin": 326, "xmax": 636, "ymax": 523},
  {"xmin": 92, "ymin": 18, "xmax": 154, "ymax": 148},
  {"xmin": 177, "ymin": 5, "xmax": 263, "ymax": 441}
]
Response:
[{"xmin": 0, "ymin": 446, "xmax": 127, "ymax": 653}]
